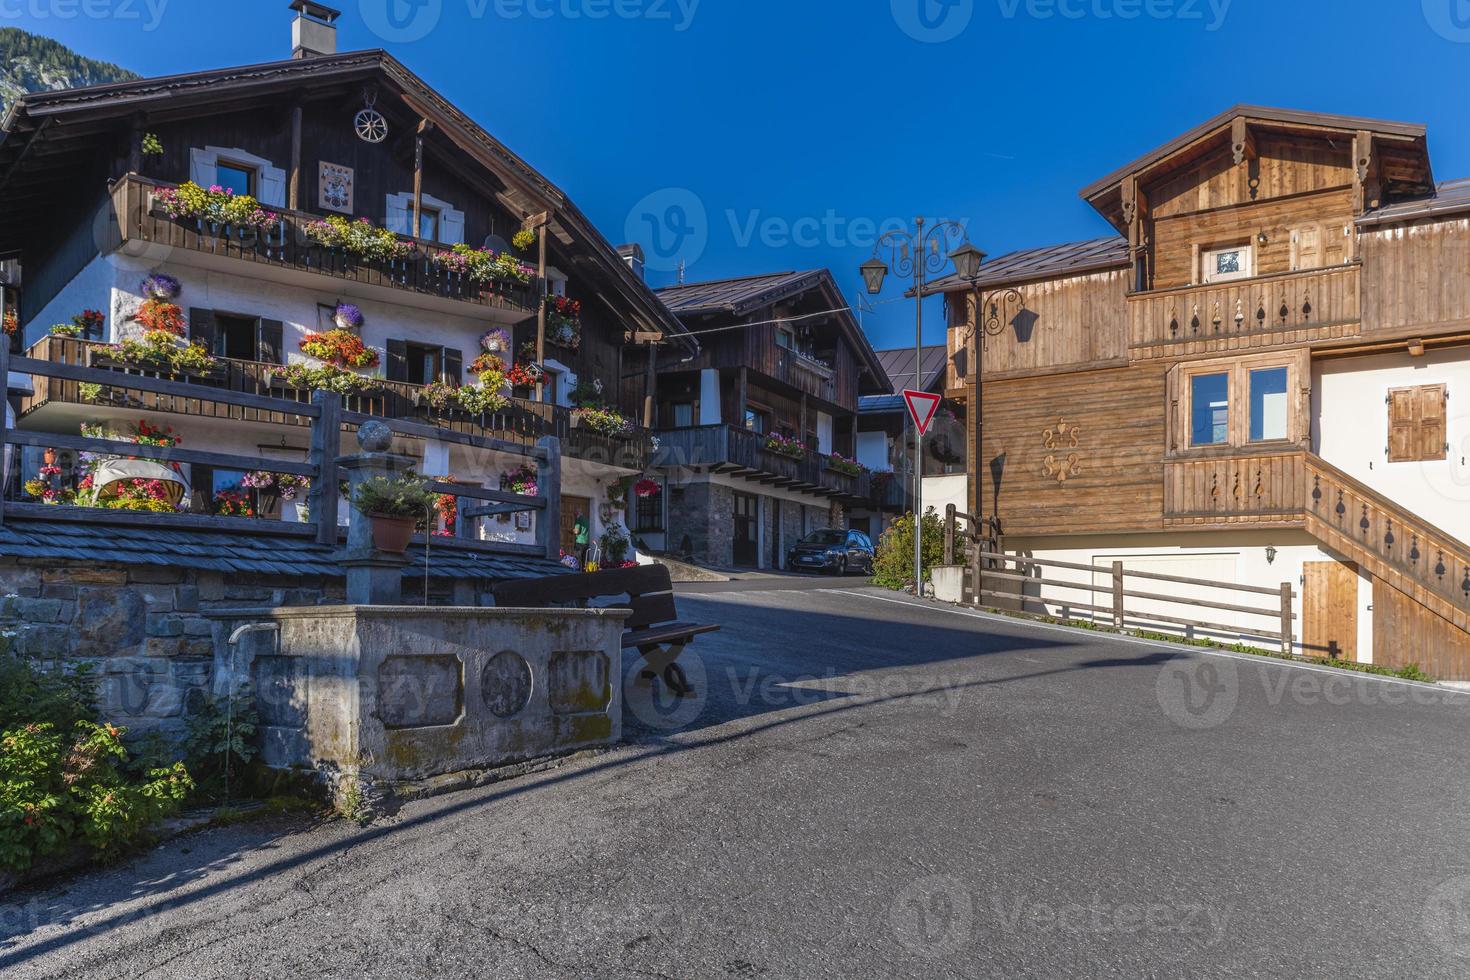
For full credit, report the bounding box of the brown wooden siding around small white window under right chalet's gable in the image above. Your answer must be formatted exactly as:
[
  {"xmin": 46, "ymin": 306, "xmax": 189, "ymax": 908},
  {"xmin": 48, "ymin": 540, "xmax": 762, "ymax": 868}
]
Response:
[{"xmin": 1152, "ymin": 187, "xmax": 1352, "ymax": 289}]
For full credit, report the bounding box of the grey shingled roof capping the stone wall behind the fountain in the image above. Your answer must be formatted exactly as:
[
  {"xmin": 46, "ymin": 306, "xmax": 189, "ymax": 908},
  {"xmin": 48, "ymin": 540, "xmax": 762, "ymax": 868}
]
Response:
[{"xmin": 0, "ymin": 519, "xmax": 566, "ymax": 580}]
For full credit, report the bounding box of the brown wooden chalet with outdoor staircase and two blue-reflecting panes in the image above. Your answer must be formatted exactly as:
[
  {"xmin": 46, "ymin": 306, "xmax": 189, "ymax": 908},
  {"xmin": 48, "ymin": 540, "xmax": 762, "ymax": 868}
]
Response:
[{"xmin": 933, "ymin": 106, "xmax": 1470, "ymax": 680}]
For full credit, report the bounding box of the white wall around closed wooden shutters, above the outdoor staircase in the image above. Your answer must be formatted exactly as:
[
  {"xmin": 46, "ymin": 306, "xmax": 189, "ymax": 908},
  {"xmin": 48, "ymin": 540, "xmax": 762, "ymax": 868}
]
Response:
[{"xmin": 1313, "ymin": 350, "xmax": 1470, "ymax": 541}]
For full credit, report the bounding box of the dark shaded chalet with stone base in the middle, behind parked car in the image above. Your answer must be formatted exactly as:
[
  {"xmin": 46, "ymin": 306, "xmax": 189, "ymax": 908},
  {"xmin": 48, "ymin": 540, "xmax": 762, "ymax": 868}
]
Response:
[{"xmin": 634, "ymin": 269, "xmax": 901, "ymax": 569}]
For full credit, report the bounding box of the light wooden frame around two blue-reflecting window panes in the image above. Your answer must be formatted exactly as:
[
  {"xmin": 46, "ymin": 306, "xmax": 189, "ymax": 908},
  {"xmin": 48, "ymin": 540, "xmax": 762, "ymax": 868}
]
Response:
[{"xmin": 1167, "ymin": 350, "xmax": 1311, "ymax": 457}]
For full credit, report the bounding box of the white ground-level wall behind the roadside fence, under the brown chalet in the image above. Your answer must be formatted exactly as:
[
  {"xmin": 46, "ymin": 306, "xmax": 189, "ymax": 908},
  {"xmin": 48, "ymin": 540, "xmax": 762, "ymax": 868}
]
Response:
[{"xmin": 1005, "ymin": 530, "xmax": 1373, "ymax": 663}]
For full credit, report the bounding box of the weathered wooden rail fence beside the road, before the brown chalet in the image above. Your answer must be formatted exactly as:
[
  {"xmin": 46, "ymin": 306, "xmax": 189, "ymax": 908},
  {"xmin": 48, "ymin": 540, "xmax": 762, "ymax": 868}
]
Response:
[{"xmin": 945, "ymin": 504, "xmax": 1297, "ymax": 657}]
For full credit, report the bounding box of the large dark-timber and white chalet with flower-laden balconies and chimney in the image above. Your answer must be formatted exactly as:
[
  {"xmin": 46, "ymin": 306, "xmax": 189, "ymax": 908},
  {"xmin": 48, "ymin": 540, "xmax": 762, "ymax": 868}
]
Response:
[{"xmin": 0, "ymin": 0, "xmax": 700, "ymax": 550}]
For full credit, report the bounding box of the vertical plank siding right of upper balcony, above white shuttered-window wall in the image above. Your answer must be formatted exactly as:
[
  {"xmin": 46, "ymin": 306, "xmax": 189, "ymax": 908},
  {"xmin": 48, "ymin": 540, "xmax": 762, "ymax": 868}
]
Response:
[{"xmin": 1361, "ymin": 217, "xmax": 1470, "ymax": 334}]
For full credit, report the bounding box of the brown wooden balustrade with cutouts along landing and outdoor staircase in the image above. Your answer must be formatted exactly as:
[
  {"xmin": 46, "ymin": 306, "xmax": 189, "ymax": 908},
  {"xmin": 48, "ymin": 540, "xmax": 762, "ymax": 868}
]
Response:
[{"xmin": 1164, "ymin": 451, "xmax": 1470, "ymax": 629}]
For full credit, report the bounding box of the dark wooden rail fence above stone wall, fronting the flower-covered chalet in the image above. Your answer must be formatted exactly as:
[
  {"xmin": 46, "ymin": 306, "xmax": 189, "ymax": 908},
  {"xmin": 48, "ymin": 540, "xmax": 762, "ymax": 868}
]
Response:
[{"xmin": 0, "ymin": 345, "xmax": 562, "ymax": 560}]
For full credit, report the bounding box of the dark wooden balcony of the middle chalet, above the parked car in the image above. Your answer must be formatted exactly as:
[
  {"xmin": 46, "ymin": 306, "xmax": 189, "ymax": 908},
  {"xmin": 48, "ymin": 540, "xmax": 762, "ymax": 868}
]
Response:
[{"xmin": 654, "ymin": 425, "xmax": 876, "ymax": 501}]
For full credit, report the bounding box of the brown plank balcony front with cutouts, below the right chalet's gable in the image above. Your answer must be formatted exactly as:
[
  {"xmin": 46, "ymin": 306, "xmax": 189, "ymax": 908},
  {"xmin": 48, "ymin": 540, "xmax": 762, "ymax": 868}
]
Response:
[{"xmin": 1127, "ymin": 263, "xmax": 1363, "ymax": 360}]
